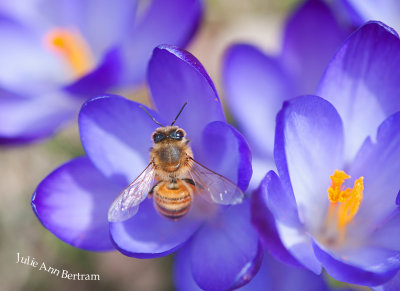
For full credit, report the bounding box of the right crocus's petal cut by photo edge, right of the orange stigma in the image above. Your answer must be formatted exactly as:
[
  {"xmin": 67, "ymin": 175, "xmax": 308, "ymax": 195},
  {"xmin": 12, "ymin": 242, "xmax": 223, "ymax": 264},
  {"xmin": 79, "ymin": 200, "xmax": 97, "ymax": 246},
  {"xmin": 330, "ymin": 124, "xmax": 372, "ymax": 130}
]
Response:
[{"xmin": 349, "ymin": 112, "xmax": 400, "ymax": 232}]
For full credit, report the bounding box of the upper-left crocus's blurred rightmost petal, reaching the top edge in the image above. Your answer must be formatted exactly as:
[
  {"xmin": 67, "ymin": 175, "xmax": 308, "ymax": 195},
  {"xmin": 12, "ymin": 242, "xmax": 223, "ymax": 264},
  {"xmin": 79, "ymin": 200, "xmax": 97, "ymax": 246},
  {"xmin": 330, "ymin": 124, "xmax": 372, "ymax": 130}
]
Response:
[{"xmin": 123, "ymin": 0, "xmax": 203, "ymax": 86}]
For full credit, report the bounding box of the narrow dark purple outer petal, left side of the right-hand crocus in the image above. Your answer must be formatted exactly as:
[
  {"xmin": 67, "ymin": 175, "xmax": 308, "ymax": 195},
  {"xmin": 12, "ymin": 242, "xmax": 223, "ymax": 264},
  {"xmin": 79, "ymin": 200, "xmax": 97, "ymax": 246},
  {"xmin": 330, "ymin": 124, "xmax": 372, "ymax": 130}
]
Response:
[{"xmin": 251, "ymin": 173, "xmax": 301, "ymax": 267}]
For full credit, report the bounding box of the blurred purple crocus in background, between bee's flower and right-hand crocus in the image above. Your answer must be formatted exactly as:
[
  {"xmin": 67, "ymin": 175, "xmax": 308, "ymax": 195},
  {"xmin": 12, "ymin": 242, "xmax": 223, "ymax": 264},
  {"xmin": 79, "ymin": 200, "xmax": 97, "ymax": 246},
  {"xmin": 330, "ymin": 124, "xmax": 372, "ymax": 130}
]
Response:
[{"xmin": 223, "ymin": 0, "xmax": 349, "ymax": 188}]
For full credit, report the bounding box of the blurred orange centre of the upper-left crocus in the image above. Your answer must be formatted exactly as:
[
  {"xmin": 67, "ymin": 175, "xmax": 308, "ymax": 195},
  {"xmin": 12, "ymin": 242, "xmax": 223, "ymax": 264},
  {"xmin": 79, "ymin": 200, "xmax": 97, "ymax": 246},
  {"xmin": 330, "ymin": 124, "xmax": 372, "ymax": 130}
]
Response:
[{"xmin": 45, "ymin": 28, "xmax": 94, "ymax": 77}]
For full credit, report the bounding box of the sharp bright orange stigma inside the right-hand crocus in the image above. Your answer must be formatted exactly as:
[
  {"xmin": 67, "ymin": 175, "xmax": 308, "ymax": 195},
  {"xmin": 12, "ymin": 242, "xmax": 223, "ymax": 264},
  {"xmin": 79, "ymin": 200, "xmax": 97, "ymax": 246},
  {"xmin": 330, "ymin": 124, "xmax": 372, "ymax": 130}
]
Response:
[{"xmin": 326, "ymin": 170, "xmax": 364, "ymax": 242}]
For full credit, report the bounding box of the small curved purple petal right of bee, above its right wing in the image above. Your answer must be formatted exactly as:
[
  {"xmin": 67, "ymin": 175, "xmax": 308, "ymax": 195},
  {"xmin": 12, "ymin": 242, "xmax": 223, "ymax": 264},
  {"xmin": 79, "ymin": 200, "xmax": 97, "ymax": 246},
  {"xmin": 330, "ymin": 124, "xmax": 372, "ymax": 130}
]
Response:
[{"xmin": 195, "ymin": 121, "xmax": 252, "ymax": 191}]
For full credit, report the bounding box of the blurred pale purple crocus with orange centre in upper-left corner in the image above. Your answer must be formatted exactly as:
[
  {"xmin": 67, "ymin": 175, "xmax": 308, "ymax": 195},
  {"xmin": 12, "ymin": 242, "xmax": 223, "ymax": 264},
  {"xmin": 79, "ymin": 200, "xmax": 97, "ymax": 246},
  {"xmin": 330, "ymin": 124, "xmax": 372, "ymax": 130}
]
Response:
[{"xmin": 0, "ymin": 0, "xmax": 202, "ymax": 143}]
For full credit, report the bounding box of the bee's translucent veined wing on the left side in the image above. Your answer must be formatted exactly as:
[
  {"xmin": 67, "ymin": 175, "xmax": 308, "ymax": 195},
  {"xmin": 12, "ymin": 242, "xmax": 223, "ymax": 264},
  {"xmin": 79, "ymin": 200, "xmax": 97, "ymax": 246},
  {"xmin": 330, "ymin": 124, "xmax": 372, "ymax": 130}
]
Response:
[{"xmin": 108, "ymin": 162, "xmax": 155, "ymax": 222}]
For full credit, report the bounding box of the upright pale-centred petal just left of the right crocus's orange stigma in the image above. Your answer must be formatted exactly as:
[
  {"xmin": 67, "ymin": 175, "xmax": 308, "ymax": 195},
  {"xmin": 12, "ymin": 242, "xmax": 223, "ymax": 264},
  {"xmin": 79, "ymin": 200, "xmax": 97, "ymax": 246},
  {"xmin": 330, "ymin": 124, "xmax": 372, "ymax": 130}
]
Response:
[{"xmin": 274, "ymin": 95, "xmax": 343, "ymax": 230}]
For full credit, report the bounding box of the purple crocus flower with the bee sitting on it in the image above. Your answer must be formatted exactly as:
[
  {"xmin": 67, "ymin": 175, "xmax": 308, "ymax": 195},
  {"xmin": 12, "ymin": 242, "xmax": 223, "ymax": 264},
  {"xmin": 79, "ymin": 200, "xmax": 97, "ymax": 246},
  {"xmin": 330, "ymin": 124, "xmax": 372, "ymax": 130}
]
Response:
[{"xmin": 32, "ymin": 45, "xmax": 256, "ymax": 290}]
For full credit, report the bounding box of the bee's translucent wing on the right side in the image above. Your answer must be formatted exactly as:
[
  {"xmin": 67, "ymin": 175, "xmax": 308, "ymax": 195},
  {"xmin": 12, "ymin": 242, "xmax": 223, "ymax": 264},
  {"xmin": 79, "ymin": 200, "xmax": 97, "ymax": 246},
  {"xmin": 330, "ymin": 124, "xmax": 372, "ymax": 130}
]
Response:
[{"xmin": 189, "ymin": 158, "xmax": 244, "ymax": 205}]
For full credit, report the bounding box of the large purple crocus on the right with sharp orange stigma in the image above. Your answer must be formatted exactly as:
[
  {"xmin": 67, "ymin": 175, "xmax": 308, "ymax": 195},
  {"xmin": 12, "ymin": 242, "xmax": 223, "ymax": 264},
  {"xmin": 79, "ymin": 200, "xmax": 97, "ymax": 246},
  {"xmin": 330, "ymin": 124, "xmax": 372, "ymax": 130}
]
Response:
[{"xmin": 252, "ymin": 22, "xmax": 400, "ymax": 286}]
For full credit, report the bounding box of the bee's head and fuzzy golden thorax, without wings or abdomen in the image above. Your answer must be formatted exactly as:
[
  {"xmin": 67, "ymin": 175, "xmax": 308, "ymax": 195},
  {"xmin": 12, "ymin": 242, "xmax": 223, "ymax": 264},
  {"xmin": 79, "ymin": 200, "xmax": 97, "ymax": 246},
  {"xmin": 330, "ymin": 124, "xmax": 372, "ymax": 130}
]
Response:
[{"xmin": 150, "ymin": 126, "xmax": 193, "ymax": 180}]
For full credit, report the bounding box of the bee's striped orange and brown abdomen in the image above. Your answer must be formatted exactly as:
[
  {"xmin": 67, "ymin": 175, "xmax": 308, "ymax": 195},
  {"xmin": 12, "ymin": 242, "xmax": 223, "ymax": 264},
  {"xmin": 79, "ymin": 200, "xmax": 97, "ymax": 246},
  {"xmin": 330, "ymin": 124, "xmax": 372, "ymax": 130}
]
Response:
[{"xmin": 154, "ymin": 179, "xmax": 193, "ymax": 219}]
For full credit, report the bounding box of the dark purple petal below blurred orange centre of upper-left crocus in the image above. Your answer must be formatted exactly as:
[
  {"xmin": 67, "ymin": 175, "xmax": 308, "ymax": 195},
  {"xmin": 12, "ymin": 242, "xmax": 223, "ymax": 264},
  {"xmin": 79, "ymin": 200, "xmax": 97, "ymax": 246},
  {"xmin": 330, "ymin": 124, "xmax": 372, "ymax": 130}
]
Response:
[{"xmin": 65, "ymin": 49, "xmax": 121, "ymax": 100}]
